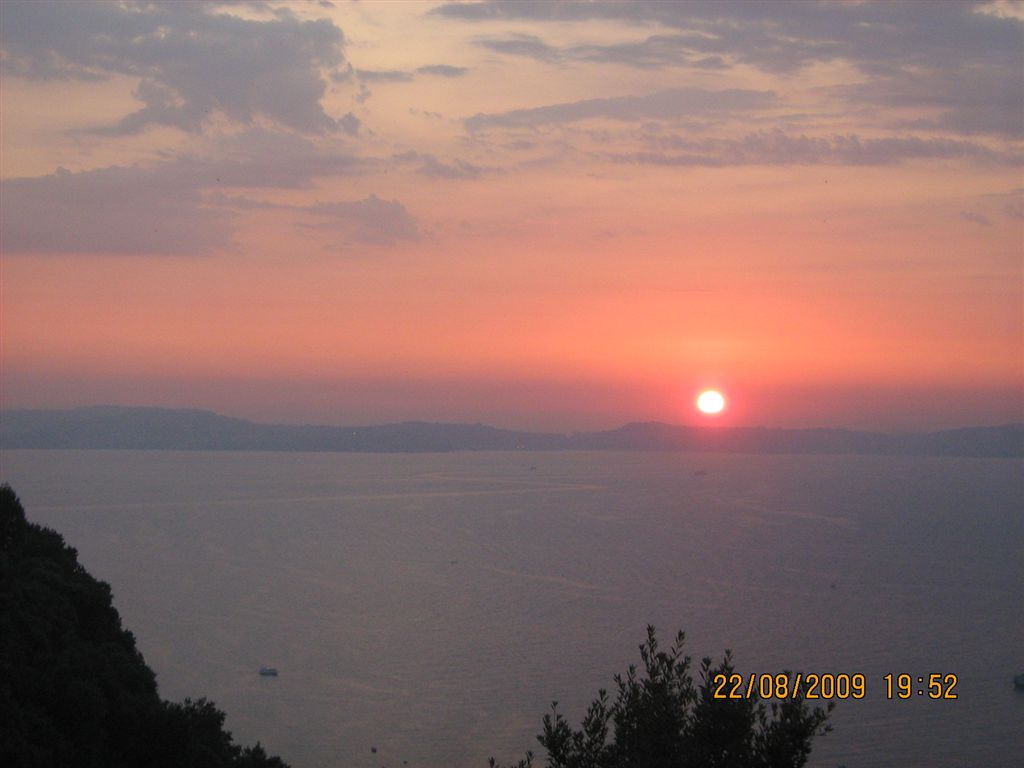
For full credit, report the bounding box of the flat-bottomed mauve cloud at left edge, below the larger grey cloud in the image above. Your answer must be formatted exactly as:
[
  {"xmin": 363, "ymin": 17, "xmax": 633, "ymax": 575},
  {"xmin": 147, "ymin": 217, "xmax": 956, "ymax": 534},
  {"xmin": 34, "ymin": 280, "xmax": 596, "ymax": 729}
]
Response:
[{"xmin": 0, "ymin": 129, "xmax": 385, "ymax": 254}]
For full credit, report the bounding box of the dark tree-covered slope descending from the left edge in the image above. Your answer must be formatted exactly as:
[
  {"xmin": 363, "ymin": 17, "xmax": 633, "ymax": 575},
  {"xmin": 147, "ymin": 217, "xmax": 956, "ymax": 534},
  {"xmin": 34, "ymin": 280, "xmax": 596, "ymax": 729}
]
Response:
[{"xmin": 0, "ymin": 484, "xmax": 287, "ymax": 768}]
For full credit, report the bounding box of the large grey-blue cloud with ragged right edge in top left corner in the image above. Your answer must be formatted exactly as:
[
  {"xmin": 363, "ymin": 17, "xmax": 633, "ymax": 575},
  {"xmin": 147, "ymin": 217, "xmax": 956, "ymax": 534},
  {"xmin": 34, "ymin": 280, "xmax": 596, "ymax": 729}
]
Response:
[{"xmin": 2, "ymin": 0, "xmax": 345, "ymax": 134}]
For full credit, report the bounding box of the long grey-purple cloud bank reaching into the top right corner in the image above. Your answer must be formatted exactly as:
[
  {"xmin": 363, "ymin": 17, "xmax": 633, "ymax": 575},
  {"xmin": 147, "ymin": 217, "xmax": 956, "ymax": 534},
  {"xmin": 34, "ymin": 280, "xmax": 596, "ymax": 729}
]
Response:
[{"xmin": 431, "ymin": 0, "xmax": 1024, "ymax": 137}]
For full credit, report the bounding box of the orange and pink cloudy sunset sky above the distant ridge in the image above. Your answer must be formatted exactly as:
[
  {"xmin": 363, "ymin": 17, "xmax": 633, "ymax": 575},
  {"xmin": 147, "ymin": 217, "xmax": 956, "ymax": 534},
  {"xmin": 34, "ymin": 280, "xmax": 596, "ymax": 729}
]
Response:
[{"xmin": 0, "ymin": 2, "xmax": 1024, "ymax": 430}]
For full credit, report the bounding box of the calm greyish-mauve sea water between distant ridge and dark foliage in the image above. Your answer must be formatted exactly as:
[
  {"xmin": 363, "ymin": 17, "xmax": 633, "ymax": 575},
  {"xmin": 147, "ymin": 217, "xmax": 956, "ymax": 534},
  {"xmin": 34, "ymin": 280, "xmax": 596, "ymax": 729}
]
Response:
[{"xmin": 0, "ymin": 451, "xmax": 1024, "ymax": 768}]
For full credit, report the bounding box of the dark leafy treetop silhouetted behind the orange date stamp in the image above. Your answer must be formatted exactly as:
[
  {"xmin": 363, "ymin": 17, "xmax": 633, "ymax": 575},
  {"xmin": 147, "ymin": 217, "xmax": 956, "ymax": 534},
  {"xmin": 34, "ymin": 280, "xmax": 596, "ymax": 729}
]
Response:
[{"xmin": 490, "ymin": 627, "xmax": 833, "ymax": 768}]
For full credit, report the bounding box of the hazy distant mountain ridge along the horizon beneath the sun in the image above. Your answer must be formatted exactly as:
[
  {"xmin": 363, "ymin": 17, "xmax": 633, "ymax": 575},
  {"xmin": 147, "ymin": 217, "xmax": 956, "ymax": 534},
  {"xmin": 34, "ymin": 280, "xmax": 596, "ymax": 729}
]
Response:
[{"xmin": 0, "ymin": 406, "xmax": 1024, "ymax": 457}]
